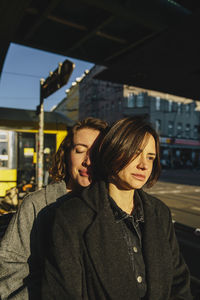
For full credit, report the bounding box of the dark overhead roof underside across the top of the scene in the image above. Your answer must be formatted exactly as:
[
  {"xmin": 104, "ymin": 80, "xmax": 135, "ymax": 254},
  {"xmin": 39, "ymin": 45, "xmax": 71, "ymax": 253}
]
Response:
[{"xmin": 0, "ymin": 0, "xmax": 200, "ymax": 100}]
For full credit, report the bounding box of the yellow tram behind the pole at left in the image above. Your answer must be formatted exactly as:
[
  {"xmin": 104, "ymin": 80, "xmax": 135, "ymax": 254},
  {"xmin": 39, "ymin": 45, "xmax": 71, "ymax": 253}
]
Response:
[{"xmin": 0, "ymin": 107, "xmax": 72, "ymax": 197}]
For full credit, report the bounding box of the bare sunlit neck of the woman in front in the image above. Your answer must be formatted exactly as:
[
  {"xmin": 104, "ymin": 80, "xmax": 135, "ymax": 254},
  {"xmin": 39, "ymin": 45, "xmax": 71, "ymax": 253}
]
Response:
[{"xmin": 108, "ymin": 183, "xmax": 134, "ymax": 214}]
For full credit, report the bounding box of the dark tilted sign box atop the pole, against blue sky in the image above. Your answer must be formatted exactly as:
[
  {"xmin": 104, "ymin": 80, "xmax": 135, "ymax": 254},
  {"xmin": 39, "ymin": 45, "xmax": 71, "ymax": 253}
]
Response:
[{"xmin": 41, "ymin": 59, "xmax": 75, "ymax": 99}]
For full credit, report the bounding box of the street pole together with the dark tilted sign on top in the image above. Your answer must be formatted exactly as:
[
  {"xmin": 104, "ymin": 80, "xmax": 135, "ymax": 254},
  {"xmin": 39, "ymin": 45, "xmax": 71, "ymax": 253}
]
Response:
[{"xmin": 36, "ymin": 60, "xmax": 75, "ymax": 190}]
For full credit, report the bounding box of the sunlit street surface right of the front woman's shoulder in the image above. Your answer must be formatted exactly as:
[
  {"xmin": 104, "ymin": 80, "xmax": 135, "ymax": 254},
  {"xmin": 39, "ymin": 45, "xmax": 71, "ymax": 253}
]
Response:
[{"xmin": 145, "ymin": 170, "xmax": 200, "ymax": 228}]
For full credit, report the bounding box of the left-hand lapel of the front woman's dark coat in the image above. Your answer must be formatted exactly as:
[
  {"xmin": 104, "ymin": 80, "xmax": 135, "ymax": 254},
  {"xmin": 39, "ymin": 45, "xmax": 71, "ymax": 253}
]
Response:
[{"xmin": 81, "ymin": 182, "xmax": 139, "ymax": 300}]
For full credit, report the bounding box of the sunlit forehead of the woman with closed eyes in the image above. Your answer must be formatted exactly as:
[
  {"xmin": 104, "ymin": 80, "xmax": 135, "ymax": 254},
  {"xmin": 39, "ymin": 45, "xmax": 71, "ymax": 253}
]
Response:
[{"xmin": 73, "ymin": 128, "xmax": 100, "ymax": 147}]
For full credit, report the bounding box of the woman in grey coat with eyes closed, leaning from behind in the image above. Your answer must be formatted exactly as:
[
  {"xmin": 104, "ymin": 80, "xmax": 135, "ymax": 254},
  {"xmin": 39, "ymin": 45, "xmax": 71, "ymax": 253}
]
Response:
[{"xmin": 0, "ymin": 117, "xmax": 107, "ymax": 300}]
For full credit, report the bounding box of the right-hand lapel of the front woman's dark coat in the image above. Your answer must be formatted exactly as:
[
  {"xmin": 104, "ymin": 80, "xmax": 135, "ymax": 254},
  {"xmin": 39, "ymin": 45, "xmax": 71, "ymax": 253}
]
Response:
[{"xmin": 141, "ymin": 192, "xmax": 172, "ymax": 300}]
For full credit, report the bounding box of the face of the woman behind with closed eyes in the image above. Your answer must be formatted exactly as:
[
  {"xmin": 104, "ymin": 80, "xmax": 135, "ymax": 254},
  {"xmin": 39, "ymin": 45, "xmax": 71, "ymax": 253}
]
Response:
[{"xmin": 67, "ymin": 128, "xmax": 100, "ymax": 189}]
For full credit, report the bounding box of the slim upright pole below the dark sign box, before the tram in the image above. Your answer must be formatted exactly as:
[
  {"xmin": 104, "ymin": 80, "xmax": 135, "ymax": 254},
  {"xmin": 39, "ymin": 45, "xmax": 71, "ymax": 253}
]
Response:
[{"xmin": 37, "ymin": 79, "xmax": 44, "ymax": 190}]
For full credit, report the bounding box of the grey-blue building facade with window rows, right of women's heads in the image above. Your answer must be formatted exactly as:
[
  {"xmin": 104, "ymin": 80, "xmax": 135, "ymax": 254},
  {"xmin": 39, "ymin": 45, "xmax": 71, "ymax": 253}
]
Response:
[{"xmin": 123, "ymin": 87, "xmax": 200, "ymax": 168}]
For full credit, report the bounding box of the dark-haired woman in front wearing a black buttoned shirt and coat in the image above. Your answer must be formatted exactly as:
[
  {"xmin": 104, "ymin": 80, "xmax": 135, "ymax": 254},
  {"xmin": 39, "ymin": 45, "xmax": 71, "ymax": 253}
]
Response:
[{"xmin": 42, "ymin": 117, "xmax": 192, "ymax": 300}]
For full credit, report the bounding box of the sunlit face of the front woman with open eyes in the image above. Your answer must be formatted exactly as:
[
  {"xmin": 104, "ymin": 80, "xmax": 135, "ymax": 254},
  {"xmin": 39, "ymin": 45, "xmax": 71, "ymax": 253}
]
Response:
[{"xmin": 115, "ymin": 134, "xmax": 156, "ymax": 190}]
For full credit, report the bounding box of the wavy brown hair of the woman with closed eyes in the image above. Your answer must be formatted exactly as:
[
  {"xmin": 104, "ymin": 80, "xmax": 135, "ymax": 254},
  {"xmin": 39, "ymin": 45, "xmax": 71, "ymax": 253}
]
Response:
[{"xmin": 49, "ymin": 117, "xmax": 108, "ymax": 183}]
